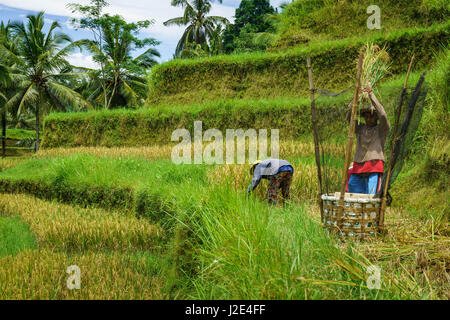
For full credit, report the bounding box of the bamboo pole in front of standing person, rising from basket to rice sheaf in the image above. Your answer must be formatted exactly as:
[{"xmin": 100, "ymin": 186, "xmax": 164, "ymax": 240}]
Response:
[{"xmin": 336, "ymin": 50, "xmax": 364, "ymax": 229}]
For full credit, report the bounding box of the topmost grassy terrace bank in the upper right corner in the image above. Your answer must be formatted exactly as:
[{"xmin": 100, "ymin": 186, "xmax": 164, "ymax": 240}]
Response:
[{"xmin": 272, "ymin": 0, "xmax": 450, "ymax": 50}]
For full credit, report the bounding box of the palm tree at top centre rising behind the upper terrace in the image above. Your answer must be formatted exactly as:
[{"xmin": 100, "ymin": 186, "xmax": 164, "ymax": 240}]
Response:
[{"xmin": 164, "ymin": 0, "xmax": 230, "ymax": 57}]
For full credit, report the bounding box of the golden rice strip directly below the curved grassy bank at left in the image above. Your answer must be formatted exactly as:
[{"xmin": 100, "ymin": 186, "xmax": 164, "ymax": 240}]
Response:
[{"xmin": 0, "ymin": 194, "xmax": 164, "ymax": 252}]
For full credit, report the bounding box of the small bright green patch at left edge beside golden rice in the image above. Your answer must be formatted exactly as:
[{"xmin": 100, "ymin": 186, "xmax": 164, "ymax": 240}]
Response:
[{"xmin": 0, "ymin": 217, "xmax": 37, "ymax": 257}]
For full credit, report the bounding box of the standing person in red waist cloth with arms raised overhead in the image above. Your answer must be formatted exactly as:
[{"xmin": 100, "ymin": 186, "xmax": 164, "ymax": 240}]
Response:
[{"xmin": 347, "ymin": 87, "xmax": 390, "ymax": 194}]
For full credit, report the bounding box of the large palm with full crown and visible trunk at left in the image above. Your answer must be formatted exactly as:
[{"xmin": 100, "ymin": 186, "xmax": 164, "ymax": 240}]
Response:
[{"xmin": 0, "ymin": 12, "xmax": 91, "ymax": 151}]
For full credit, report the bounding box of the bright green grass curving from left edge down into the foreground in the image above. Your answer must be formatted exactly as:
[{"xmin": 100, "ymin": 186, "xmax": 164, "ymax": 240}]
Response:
[{"xmin": 0, "ymin": 156, "xmax": 436, "ymax": 299}]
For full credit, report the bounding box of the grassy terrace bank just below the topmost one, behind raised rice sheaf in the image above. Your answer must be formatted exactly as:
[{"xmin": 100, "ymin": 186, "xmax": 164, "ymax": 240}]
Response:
[{"xmin": 148, "ymin": 23, "xmax": 450, "ymax": 105}]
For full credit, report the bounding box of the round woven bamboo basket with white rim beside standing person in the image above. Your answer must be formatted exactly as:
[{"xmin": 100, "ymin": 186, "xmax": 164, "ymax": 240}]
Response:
[{"xmin": 322, "ymin": 192, "xmax": 381, "ymax": 239}]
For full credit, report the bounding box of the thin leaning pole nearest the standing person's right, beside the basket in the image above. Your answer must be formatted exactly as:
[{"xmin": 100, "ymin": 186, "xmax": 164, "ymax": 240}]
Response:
[{"xmin": 379, "ymin": 55, "xmax": 415, "ymax": 230}]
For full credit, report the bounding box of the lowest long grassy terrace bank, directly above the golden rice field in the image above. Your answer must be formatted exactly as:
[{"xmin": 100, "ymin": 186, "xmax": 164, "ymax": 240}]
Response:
[{"xmin": 42, "ymin": 72, "xmax": 419, "ymax": 148}]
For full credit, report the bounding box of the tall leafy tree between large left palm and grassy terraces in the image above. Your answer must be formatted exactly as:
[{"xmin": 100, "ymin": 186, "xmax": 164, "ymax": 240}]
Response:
[{"xmin": 77, "ymin": 15, "xmax": 161, "ymax": 109}]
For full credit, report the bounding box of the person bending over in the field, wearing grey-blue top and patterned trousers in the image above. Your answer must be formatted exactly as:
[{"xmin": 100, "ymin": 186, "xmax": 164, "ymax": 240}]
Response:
[{"xmin": 247, "ymin": 159, "xmax": 294, "ymax": 205}]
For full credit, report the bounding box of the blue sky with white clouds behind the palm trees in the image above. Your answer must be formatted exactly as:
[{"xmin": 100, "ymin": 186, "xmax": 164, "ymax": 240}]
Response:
[{"xmin": 0, "ymin": 0, "xmax": 286, "ymax": 68}]
